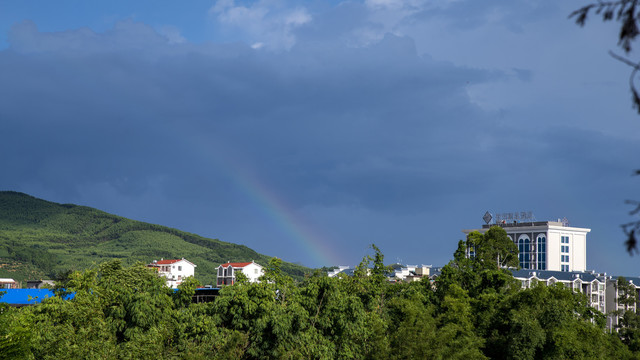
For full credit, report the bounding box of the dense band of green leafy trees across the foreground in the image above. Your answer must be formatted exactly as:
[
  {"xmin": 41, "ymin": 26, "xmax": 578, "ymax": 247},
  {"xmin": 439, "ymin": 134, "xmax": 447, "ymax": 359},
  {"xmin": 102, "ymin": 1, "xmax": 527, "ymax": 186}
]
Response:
[{"xmin": 0, "ymin": 242, "xmax": 640, "ymax": 360}]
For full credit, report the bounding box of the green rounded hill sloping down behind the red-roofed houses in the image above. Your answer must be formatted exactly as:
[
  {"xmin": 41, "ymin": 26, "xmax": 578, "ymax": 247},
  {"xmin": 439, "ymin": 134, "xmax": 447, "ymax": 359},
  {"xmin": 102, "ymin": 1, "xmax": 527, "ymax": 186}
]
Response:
[{"xmin": 0, "ymin": 191, "xmax": 310, "ymax": 284}]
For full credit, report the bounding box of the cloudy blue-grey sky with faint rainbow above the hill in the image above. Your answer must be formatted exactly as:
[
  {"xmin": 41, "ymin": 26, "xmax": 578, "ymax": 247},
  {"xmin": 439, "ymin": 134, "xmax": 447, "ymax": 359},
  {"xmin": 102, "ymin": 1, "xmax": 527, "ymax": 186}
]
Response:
[{"xmin": 0, "ymin": 0, "xmax": 640, "ymax": 276}]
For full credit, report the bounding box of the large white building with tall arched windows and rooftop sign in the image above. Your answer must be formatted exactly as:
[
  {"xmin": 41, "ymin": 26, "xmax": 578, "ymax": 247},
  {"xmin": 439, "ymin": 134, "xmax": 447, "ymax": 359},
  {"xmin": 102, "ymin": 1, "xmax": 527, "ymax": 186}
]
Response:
[{"xmin": 462, "ymin": 221, "xmax": 591, "ymax": 272}]
